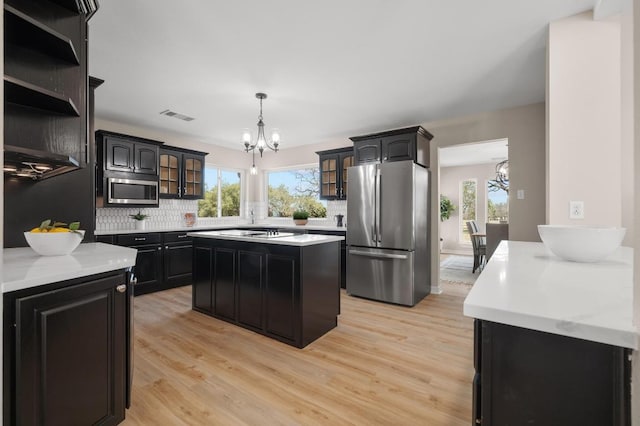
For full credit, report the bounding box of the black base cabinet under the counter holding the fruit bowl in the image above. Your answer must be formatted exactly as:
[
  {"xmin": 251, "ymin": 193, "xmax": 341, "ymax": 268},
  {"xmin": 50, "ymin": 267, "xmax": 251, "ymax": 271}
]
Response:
[{"xmin": 3, "ymin": 271, "xmax": 131, "ymax": 425}]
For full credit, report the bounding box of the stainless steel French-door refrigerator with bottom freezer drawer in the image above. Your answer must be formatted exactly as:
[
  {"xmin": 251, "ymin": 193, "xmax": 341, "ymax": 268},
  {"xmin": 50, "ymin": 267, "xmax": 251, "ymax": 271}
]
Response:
[{"xmin": 347, "ymin": 161, "xmax": 431, "ymax": 306}]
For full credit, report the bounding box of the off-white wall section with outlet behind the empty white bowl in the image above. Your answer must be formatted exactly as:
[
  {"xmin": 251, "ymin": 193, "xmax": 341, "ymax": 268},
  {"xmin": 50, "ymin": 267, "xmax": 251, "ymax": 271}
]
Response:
[{"xmin": 547, "ymin": 12, "xmax": 631, "ymax": 233}]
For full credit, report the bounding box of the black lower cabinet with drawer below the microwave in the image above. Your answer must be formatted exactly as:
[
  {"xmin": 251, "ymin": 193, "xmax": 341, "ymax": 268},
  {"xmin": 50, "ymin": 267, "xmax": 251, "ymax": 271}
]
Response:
[{"xmin": 116, "ymin": 233, "xmax": 163, "ymax": 296}]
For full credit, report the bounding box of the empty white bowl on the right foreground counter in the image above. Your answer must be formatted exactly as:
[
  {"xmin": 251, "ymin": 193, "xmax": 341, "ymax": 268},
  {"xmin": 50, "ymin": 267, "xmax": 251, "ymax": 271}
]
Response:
[{"xmin": 538, "ymin": 225, "xmax": 627, "ymax": 262}]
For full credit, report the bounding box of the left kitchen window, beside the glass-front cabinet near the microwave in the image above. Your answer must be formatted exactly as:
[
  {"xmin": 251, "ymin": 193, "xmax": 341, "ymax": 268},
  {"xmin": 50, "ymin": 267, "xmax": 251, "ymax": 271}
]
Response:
[{"xmin": 198, "ymin": 166, "xmax": 242, "ymax": 217}]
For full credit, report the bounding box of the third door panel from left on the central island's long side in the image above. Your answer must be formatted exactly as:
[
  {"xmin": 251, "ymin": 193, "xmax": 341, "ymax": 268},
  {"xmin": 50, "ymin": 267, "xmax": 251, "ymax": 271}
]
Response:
[{"xmin": 238, "ymin": 250, "xmax": 265, "ymax": 331}]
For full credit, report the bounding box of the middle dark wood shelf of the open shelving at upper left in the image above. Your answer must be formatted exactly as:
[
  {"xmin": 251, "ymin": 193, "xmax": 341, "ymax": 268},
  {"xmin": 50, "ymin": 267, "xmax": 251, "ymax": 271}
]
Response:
[{"xmin": 4, "ymin": 75, "xmax": 80, "ymax": 117}]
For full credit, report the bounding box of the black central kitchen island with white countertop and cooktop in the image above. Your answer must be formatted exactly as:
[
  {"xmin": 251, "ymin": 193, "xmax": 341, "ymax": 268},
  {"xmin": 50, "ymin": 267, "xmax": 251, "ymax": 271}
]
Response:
[{"xmin": 188, "ymin": 229, "xmax": 344, "ymax": 348}]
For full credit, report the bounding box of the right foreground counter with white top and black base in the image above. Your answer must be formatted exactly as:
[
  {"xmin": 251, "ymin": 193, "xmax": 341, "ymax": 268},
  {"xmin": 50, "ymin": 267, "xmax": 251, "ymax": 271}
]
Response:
[{"xmin": 464, "ymin": 241, "xmax": 638, "ymax": 426}]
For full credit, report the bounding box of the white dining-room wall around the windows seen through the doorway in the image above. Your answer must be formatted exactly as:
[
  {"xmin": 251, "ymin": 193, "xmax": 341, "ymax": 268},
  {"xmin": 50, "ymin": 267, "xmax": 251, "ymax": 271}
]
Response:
[{"xmin": 440, "ymin": 164, "xmax": 496, "ymax": 254}]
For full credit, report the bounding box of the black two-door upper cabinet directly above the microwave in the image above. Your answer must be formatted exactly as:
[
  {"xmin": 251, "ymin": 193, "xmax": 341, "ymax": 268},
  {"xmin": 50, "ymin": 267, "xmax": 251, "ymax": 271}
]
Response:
[{"xmin": 96, "ymin": 130, "xmax": 160, "ymax": 175}]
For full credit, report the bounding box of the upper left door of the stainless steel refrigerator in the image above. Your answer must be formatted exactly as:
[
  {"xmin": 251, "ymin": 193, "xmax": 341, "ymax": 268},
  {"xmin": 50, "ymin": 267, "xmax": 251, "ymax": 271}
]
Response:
[{"xmin": 347, "ymin": 164, "xmax": 377, "ymax": 247}]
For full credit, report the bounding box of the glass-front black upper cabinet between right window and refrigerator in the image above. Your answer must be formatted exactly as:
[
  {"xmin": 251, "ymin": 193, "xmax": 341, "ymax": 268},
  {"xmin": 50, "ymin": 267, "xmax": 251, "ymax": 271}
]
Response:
[{"xmin": 316, "ymin": 147, "xmax": 354, "ymax": 200}]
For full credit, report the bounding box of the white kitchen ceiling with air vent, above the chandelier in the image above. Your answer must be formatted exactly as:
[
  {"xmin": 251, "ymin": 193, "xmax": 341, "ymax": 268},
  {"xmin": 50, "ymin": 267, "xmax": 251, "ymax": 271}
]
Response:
[{"xmin": 89, "ymin": 0, "xmax": 597, "ymax": 149}]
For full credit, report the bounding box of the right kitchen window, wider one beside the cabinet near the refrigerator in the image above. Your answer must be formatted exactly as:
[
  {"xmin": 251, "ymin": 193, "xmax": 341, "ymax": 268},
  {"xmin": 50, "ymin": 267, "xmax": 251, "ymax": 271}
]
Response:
[{"xmin": 266, "ymin": 166, "xmax": 327, "ymax": 217}]
